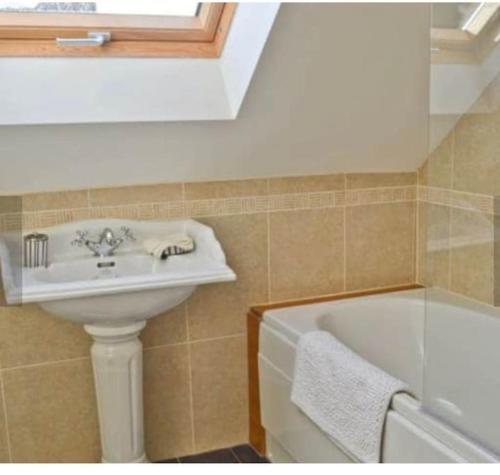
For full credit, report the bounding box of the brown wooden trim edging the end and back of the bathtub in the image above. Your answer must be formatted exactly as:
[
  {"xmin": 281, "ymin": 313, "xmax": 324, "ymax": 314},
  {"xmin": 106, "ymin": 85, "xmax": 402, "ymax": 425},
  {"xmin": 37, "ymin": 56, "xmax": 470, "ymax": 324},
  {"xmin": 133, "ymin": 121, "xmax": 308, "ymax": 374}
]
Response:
[{"xmin": 247, "ymin": 284, "xmax": 424, "ymax": 456}]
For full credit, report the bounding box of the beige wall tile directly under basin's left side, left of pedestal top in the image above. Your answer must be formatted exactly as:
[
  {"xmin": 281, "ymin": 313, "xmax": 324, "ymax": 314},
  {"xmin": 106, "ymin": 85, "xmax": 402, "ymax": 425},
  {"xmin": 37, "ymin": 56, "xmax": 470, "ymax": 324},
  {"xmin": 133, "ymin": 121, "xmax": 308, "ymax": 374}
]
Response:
[{"xmin": 0, "ymin": 305, "xmax": 91, "ymax": 368}]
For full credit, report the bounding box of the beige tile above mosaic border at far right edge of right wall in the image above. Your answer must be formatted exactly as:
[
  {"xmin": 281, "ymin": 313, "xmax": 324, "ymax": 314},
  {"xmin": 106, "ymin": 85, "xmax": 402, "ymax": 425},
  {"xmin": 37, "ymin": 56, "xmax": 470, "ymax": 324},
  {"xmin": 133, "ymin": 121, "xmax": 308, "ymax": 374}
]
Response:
[{"xmin": 453, "ymin": 114, "xmax": 500, "ymax": 195}]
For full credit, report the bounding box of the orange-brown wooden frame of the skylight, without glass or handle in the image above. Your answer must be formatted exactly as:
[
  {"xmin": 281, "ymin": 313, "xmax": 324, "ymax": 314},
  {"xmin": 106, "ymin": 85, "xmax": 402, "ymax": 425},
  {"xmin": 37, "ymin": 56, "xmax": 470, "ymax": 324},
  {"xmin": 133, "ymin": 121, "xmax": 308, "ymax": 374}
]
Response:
[{"xmin": 0, "ymin": 3, "xmax": 236, "ymax": 58}]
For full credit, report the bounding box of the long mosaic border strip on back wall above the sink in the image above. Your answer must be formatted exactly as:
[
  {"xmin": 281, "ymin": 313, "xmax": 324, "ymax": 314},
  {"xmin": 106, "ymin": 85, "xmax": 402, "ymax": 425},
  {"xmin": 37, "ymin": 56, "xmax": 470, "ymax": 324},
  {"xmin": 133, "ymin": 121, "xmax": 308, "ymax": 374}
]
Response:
[{"xmin": 0, "ymin": 185, "xmax": 417, "ymax": 231}]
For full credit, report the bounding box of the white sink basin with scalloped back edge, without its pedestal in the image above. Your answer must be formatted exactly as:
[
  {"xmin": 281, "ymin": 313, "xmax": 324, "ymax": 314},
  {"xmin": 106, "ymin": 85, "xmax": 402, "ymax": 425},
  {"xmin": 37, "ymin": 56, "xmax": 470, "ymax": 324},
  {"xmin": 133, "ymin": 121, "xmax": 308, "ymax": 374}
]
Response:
[{"xmin": 0, "ymin": 219, "xmax": 236, "ymax": 325}]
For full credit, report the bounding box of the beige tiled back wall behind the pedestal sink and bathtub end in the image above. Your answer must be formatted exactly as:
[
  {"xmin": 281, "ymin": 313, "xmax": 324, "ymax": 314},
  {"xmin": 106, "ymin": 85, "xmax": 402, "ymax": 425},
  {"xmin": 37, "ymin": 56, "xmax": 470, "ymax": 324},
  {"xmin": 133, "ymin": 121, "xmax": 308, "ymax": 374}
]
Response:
[{"xmin": 0, "ymin": 173, "xmax": 416, "ymax": 462}]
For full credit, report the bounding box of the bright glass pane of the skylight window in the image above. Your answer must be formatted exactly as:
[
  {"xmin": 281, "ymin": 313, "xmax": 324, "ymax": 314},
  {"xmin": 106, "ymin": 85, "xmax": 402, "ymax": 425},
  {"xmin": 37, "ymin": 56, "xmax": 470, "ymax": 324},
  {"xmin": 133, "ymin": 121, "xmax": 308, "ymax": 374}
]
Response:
[{"xmin": 0, "ymin": 0, "xmax": 198, "ymax": 17}]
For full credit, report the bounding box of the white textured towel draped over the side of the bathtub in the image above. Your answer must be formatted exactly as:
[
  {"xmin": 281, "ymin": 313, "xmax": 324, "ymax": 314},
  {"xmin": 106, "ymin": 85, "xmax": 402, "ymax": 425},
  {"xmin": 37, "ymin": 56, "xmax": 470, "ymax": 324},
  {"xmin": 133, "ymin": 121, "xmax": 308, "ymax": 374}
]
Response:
[{"xmin": 291, "ymin": 331, "xmax": 407, "ymax": 462}]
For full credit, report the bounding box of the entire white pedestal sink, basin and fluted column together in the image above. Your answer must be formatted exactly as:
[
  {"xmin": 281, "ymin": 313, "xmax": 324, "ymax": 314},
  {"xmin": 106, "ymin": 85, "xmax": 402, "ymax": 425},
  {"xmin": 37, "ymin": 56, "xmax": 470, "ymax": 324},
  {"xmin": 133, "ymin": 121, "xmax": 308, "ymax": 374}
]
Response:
[{"xmin": 0, "ymin": 219, "xmax": 236, "ymax": 462}]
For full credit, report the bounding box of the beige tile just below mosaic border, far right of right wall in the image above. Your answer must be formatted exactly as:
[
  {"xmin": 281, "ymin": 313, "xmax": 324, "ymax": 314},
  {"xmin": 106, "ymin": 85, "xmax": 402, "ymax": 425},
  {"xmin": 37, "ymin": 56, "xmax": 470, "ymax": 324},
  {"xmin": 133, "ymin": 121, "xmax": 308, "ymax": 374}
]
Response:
[{"xmin": 451, "ymin": 209, "xmax": 494, "ymax": 304}]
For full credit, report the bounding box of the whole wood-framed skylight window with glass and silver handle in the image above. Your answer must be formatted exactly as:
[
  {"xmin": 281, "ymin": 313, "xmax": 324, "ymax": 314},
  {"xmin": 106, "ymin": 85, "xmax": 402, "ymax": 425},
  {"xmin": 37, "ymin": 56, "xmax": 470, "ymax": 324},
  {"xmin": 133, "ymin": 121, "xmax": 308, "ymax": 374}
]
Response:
[{"xmin": 0, "ymin": 0, "xmax": 235, "ymax": 57}]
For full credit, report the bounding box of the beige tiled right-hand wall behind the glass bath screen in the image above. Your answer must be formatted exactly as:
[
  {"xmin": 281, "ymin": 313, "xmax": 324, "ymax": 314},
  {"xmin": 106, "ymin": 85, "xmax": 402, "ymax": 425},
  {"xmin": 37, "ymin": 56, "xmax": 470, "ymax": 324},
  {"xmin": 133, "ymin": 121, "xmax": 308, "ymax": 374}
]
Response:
[{"xmin": 417, "ymin": 78, "xmax": 500, "ymax": 305}]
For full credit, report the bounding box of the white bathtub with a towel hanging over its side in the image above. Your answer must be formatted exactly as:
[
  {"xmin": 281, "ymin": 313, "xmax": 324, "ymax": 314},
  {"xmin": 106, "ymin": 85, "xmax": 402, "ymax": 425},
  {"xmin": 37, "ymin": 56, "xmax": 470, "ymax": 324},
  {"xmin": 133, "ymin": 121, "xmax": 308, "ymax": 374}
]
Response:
[{"xmin": 259, "ymin": 290, "xmax": 500, "ymax": 462}]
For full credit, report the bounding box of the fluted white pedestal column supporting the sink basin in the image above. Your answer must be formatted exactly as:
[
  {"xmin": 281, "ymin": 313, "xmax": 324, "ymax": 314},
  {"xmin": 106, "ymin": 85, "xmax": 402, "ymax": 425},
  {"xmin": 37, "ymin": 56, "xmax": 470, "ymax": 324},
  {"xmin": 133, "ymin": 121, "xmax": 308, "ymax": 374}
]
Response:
[{"xmin": 85, "ymin": 321, "xmax": 147, "ymax": 463}]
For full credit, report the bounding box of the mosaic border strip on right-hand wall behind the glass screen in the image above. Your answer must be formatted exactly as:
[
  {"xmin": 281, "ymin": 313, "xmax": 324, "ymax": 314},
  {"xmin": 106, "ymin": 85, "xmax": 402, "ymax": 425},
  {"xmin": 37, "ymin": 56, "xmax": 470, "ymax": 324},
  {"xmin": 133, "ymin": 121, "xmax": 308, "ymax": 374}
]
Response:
[{"xmin": 417, "ymin": 186, "xmax": 495, "ymax": 214}]
